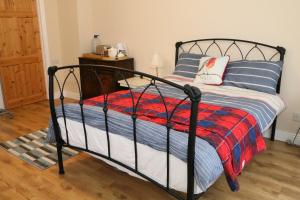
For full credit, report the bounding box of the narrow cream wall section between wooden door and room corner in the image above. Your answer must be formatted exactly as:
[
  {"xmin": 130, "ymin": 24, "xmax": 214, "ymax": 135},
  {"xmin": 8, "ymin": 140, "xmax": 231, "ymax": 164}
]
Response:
[{"xmin": 44, "ymin": 0, "xmax": 93, "ymax": 93}]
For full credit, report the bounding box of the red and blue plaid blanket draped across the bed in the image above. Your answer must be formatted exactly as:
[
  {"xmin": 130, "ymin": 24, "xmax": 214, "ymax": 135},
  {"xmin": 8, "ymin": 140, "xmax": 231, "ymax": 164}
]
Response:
[{"xmin": 85, "ymin": 91, "xmax": 266, "ymax": 191}]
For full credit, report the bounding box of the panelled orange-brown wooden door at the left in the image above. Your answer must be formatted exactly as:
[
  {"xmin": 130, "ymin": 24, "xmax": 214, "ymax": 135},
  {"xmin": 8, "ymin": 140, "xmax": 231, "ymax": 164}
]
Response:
[{"xmin": 0, "ymin": 0, "xmax": 46, "ymax": 108}]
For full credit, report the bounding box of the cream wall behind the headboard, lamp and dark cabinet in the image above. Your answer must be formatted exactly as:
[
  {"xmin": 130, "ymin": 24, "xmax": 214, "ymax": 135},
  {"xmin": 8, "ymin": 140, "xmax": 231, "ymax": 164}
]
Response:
[{"xmin": 93, "ymin": 0, "xmax": 300, "ymax": 135}]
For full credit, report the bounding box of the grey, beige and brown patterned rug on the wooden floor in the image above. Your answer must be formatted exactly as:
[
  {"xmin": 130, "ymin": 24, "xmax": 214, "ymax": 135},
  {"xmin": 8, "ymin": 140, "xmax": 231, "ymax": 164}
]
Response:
[{"xmin": 0, "ymin": 129, "xmax": 79, "ymax": 170}]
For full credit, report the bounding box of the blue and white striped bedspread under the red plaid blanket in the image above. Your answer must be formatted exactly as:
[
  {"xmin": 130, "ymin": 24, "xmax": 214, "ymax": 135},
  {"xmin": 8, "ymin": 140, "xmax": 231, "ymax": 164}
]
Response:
[{"xmin": 48, "ymin": 84, "xmax": 276, "ymax": 191}]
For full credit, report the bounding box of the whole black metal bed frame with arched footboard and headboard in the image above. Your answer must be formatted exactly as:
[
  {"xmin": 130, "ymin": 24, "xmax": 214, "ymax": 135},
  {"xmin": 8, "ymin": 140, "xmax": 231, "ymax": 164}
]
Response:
[{"xmin": 48, "ymin": 38, "xmax": 285, "ymax": 200}]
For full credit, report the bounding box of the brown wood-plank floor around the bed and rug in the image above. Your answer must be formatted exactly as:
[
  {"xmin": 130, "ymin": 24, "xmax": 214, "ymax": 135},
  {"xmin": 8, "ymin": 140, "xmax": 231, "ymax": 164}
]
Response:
[{"xmin": 0, "ymin": 102, "xmax": 300, "ymax": 200}]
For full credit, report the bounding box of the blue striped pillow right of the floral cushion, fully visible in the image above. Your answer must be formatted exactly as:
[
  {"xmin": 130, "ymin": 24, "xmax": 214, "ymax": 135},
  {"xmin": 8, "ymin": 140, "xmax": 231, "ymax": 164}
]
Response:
[{"xmin": 223, "ymin": 60, "xmax": 283, "ymax": 94}]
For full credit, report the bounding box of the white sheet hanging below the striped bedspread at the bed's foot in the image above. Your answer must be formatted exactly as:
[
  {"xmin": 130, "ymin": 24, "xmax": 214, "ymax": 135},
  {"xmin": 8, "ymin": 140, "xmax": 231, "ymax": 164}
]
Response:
[{"xmin": 58, "ymin": 118, "xmax": 214, "ymax": 193}]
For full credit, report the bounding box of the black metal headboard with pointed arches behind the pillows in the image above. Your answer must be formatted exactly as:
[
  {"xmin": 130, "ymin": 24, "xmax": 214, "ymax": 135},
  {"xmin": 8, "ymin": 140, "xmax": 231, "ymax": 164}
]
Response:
[{"xmin": 175, "ymin": 38, "xmax": 286, "ymax": 93}]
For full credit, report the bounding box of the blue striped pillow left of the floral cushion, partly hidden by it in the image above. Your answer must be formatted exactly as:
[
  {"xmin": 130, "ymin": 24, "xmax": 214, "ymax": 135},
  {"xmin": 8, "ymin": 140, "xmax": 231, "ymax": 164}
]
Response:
[{"xmin": 173, "ymin": 53, "xmax": 204, "ymax": 78}]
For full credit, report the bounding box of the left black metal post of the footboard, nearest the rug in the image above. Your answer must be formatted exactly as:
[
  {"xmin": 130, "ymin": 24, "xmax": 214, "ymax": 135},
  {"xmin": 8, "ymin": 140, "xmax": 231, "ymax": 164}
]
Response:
[{"xmin": 48, "ymin": 66, "xmax": 65, "ymax": 174}]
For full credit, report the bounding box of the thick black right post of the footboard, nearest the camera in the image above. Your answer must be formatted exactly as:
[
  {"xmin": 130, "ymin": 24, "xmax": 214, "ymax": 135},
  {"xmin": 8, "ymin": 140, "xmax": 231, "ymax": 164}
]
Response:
[{"xmin": 184, "ymin": 85, "xmax": 201, "ymax": 200}]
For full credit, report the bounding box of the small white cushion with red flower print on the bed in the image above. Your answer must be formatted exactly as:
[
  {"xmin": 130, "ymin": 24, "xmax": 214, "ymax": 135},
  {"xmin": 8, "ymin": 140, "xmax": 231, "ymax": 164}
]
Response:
[{"xmin": 194, "ymin": 56, "xmax": 229, "ymax": 85}]
